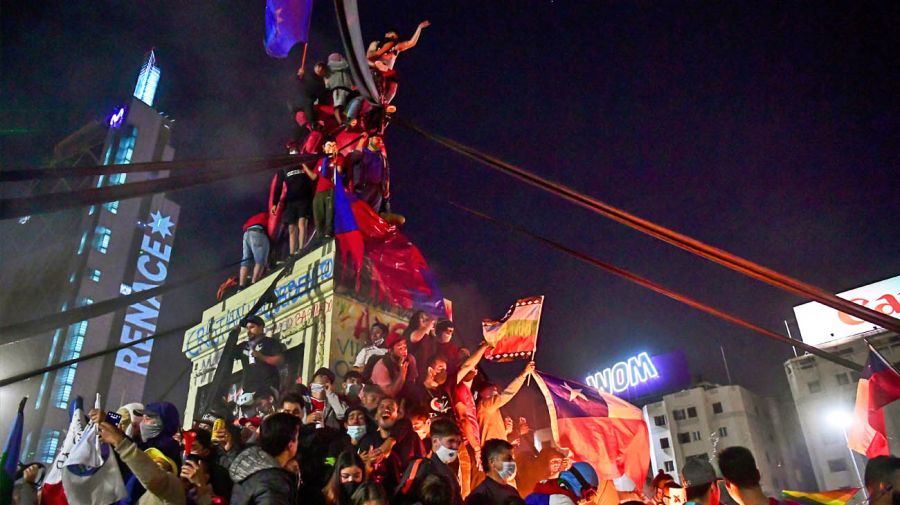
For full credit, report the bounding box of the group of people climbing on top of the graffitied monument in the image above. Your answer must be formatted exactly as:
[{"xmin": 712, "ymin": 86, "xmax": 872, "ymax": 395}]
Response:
[{"xmin": 235, "ymin": 21, "xmax": 430, "ymax": 290}]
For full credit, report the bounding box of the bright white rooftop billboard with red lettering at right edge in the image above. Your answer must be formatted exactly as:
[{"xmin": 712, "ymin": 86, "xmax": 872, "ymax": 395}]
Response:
[{"xmin": 794, "ymin": 276, "xmax": 900, "ymax": 346}]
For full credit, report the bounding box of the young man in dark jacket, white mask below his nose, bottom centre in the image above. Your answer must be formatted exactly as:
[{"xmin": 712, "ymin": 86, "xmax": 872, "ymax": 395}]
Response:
[{"xmin": 395, "ymin": 417, "xmax": 462, "ymax": 505}]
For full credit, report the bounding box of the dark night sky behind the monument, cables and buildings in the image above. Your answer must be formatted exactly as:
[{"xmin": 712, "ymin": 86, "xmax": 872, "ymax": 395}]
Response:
[{"xmin": 0, "ymin": 0, "xmax": 900, "ymax": 406}]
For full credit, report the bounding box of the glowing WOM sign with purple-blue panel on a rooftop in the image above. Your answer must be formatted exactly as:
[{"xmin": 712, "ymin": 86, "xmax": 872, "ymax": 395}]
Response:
[{"xmin": 584, "ymin": 351, "xmax": 691, "ymax": 399}]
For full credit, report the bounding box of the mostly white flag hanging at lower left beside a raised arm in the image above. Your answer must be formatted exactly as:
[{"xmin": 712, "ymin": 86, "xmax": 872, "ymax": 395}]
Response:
[{"xmin": 62, "ymin": 424, "xmax": 128, "ymax": 505}]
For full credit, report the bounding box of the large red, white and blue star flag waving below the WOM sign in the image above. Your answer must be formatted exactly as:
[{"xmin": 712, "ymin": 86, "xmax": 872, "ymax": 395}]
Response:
[{"xmin": 534, "ymin": 372, "xmax": 650, "ymax": 482}]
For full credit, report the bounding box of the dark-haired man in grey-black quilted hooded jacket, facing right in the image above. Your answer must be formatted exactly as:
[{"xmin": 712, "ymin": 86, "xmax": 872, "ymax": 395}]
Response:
[{"xmin": 229, "ymin": 412, "xmax": 300, "ymax": 505}]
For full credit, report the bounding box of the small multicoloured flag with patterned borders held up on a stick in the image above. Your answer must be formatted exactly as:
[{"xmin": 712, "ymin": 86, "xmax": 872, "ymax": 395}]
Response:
[{"xmin": 481, "ymin": 296, "xmax": 544, "ymax": 362}]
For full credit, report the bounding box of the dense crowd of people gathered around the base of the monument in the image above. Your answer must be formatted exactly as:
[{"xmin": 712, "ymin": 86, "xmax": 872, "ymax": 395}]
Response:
[{"xmin": 18, "ymin": 312, "xmax": 900, "ymax": 505}]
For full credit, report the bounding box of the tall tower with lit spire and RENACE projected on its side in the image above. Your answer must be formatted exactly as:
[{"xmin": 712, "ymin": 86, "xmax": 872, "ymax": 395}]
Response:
[{"xmin": 0, "ymin": 51, "xmax": 179, "ymax": 461}]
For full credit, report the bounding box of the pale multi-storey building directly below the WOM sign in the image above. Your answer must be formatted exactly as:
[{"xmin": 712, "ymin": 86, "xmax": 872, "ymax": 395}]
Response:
[{"xmin": 644, "ymin": 383, "xmax": 808, "ymax": 496}]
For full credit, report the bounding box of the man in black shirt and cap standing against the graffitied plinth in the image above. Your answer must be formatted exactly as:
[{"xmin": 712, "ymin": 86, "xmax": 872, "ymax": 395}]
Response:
[{"xmin": 236, "ymin": 315, "xmax": 285, "ymax": 404}]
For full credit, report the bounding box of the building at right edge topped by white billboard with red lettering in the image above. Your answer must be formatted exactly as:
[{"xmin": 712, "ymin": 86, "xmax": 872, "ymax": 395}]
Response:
[{"xmin": 784, "ymin": 277, "xmax": 900, "ymax": 489}]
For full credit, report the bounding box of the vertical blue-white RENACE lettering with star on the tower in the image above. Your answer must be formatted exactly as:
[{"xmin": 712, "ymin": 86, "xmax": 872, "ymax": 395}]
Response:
[{"xmin": 109, "ymin": 195, "xmax": 179, "ymax": 401}]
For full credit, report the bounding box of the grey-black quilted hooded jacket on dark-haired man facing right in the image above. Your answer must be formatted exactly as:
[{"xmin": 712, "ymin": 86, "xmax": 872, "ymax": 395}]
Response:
[{"xmin": 228, "ymin": 447, "xmax": 298, "ymax": 505}]
